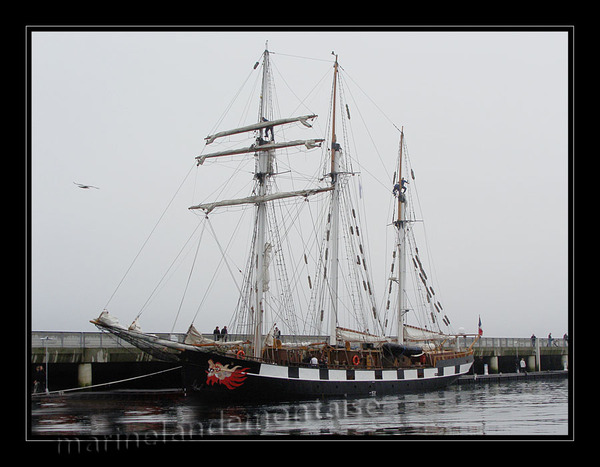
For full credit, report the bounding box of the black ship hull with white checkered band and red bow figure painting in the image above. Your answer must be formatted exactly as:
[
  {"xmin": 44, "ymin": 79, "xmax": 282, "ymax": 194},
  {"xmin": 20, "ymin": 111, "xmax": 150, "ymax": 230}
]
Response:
[{"xmin": 182, "ymin": 352, "xmax": 473, "ymax": 401}]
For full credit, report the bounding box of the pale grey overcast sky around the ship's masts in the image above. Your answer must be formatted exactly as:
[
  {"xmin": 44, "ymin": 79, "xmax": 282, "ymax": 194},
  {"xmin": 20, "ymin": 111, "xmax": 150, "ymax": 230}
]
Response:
[{"xmin": 31, "ymin": 31, "xmax": 570, "ymax": 337}]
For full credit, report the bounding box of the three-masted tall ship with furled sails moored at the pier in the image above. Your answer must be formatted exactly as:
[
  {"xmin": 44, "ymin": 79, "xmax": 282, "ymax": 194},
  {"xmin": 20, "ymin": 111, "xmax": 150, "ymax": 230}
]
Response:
[{"xmin": 91, "ymin": 47, "xmax": 473, "ymax": 400}]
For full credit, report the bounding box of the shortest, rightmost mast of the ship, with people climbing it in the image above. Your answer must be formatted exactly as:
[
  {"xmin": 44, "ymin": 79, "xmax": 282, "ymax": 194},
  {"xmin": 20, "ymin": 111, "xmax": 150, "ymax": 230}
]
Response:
[{"xmin": 394, "ymin": 127, "xmax": 406, "ymax": 344}]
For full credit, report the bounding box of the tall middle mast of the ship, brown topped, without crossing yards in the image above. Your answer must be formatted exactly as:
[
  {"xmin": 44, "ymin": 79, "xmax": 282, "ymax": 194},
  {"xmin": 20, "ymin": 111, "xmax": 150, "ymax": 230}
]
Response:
[{"xmin": 329, "ymin": 55, "xmax": 341, "ymax": 345}]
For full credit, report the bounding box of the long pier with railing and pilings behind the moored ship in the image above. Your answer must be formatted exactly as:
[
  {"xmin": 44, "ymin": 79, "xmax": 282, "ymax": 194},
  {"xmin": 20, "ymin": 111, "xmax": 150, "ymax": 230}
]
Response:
[{"xmin": 31, "ymin": 331, "xmax": 569, "ymax": 391}]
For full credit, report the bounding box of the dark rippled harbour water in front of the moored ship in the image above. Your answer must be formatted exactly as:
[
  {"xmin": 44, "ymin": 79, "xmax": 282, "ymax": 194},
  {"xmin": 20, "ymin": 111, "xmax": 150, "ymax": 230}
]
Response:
[{"xmin": 31, "ymin": 379, "xmax": 569, "ymax": 443}]
